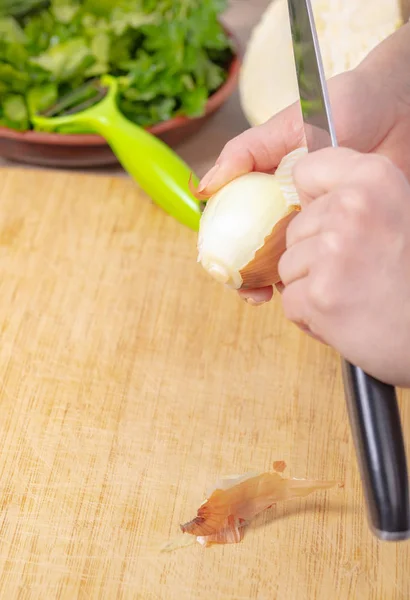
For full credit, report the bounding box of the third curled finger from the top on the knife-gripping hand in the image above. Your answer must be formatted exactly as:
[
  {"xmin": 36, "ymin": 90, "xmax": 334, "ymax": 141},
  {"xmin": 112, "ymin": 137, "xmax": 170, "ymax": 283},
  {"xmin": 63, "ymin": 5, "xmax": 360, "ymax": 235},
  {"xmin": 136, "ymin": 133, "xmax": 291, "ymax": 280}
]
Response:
[{"xmin": 278, "ymin": 236, "xmax": 323, "ymax": 287}]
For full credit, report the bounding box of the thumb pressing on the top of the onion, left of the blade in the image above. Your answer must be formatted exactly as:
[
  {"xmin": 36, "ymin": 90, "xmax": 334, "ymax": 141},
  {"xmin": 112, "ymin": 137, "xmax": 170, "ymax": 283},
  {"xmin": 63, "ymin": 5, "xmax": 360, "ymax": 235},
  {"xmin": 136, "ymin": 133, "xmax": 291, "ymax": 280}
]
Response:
[{"xmin": 198, "ymin": 103, "xmax": 304, "ymax": 197}]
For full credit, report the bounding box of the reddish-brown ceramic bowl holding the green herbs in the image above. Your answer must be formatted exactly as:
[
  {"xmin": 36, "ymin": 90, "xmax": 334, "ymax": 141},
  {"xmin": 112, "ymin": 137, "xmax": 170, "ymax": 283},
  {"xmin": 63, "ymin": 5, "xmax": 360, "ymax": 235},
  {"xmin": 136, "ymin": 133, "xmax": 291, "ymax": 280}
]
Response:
[{"xmin": 0, "ymin": 34, "xmax": 241, "ymax": 168}]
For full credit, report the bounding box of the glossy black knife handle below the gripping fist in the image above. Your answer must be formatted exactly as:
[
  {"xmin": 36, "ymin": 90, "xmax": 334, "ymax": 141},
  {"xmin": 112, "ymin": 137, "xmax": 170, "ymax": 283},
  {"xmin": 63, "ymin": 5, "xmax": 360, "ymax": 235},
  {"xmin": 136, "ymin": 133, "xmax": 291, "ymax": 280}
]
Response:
[{"xmin": 342, "ymin": 360, "xmax": 410, "ymax": 541}]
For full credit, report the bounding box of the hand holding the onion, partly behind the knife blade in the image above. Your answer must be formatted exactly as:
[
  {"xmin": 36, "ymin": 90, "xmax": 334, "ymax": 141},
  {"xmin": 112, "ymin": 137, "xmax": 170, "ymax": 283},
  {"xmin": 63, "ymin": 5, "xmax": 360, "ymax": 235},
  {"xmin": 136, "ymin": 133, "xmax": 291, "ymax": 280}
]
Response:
[{"xmin": 198, "ymin": 24, "xmax": 410, "ymax": 304}]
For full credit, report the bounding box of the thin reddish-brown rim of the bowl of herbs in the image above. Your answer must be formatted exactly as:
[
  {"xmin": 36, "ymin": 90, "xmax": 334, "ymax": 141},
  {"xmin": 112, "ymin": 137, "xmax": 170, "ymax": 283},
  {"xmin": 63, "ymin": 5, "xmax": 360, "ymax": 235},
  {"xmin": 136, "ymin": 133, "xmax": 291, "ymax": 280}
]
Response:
[{"xmin": 0, "ymin": 25, "xmax": 242, "ymax": 146}]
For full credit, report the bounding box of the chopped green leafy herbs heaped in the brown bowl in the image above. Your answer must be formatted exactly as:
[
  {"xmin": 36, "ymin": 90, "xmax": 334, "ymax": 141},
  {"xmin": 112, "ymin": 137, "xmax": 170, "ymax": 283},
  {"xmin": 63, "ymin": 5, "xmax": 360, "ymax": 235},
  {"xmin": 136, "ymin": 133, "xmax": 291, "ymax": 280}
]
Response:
[{"xmin": 0, "ymin": 0, "xmax": 232, "ymax": 130}]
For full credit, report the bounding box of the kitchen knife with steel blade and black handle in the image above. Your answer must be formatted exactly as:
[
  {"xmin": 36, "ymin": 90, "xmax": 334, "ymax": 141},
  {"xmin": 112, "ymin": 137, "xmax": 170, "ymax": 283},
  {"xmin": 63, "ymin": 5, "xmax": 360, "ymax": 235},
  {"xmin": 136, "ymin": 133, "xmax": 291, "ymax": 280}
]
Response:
[{"xmin": 288, "ymin": 0, "xmax": 410, "ymax": 541}]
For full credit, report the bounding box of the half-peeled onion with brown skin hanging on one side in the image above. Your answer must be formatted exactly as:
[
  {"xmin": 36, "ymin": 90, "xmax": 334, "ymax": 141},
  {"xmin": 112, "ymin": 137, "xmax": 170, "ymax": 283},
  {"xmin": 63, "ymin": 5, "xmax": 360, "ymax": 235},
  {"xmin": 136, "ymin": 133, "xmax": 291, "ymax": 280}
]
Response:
[{"xmin": 198, "ymin": 148, "xmax": 307, "ymax": 289}]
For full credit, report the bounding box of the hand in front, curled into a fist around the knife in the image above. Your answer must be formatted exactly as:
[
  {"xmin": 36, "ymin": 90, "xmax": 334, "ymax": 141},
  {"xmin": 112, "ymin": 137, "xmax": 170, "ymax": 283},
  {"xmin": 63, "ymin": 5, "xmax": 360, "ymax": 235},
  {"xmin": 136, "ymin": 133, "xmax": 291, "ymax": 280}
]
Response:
[{"xmin": 279, "ymin": 148, "xmax": 410, "ymax": 387}]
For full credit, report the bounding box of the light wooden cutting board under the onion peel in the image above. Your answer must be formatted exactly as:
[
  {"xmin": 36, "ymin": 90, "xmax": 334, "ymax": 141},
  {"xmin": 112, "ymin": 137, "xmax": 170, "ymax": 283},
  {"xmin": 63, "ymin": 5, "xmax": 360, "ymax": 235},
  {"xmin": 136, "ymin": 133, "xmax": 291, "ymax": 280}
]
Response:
[{"xmin": 0, "ymin": 169, "xmax": 410, "ymax": 600}]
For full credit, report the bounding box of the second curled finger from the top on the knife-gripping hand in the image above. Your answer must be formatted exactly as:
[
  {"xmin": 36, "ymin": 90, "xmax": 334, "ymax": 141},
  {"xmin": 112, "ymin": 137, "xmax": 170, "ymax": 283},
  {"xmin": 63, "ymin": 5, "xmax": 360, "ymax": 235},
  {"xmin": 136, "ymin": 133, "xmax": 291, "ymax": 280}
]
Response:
[{"xmin": 286, "ymin": 193, "xmax": 338, "ymax": 248}]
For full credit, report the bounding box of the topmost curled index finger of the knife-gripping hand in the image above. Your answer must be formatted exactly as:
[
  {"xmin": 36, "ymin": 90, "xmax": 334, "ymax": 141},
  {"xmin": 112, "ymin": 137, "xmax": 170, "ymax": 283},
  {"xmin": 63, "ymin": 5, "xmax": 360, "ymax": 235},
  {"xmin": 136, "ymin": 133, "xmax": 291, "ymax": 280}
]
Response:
[{"xmin": 293, "ymin": 148, "xmax": 362, "ymax": 207}]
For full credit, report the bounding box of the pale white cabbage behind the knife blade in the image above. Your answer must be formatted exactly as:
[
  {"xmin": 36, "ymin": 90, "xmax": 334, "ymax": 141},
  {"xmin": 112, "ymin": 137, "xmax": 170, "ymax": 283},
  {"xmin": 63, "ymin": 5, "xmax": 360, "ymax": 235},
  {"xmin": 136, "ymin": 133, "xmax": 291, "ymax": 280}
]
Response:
[{"xmin": 239, "ymin": 0, "xmax": 402, "ymax": 125}]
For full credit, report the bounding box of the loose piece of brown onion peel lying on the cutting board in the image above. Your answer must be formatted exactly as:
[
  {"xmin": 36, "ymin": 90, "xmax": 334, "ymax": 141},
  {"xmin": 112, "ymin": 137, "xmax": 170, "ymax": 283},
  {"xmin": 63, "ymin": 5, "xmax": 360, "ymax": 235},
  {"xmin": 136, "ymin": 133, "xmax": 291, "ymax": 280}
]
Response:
[{"xmin": 181, "ymin": 461, "xmax": 337, "ymax": 546}]
